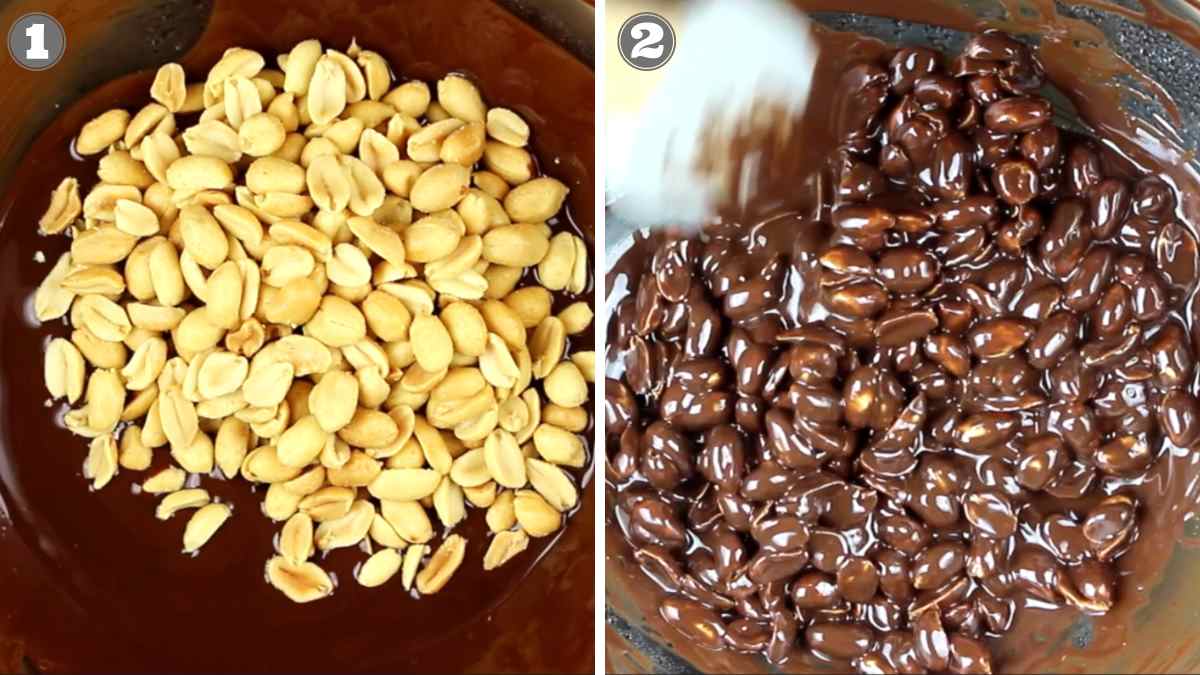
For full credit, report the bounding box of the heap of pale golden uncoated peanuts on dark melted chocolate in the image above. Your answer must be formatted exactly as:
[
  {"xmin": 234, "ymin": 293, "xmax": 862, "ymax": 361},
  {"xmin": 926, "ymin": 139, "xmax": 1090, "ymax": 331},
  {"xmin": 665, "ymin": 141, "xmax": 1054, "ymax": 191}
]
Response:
[{"xmin": 34, "ymin": 40, "xmax": 595, "ymax": 602}]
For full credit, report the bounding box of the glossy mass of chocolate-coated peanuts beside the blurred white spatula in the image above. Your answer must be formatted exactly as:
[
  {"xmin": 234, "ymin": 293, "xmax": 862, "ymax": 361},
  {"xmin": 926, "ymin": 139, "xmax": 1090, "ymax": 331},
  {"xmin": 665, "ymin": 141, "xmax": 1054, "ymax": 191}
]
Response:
[{"xmin": 605, "ymin": 22, "xmax": 1200, "ymax": 673}]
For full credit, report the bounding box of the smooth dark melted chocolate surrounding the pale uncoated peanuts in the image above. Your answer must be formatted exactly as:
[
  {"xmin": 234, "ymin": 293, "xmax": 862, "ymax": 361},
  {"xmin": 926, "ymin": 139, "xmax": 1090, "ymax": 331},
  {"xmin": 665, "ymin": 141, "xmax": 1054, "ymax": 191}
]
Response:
[{"xmin": 0, "ymin": 0, "xmax": 595, "ymax": 673}]
